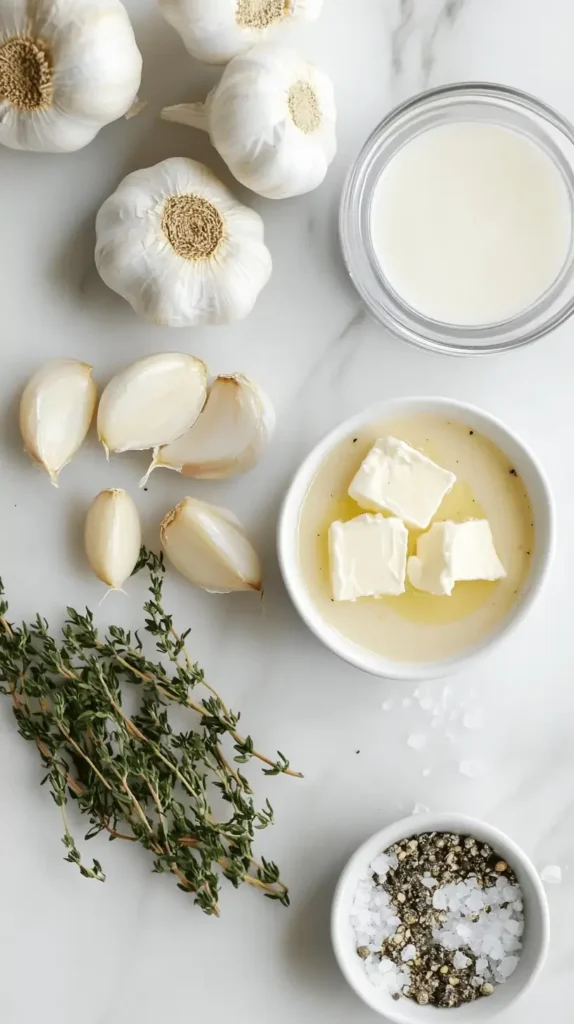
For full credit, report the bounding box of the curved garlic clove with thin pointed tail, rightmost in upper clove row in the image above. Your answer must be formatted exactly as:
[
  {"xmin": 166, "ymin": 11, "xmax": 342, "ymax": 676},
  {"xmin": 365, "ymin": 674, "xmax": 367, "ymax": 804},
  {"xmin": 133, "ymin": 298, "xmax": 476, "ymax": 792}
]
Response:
[{"xmin": 141, "ymin": 374, "xmax": 275, "ymax": 486}]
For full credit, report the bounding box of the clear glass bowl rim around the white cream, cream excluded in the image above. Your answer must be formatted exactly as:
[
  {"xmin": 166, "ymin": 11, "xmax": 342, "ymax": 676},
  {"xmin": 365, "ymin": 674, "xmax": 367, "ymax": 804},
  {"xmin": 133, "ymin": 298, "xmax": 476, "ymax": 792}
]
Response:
[{"xmin": 340, "ymin": 83, "xmax": 574, "ymax": 355}]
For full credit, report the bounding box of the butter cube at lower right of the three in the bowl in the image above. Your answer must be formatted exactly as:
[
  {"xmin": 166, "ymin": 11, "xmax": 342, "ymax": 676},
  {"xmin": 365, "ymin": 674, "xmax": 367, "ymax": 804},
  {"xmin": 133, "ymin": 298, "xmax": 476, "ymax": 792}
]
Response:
[{"xmin": 407, "ymin": 519, "xmax": 506, "ymax": 595}]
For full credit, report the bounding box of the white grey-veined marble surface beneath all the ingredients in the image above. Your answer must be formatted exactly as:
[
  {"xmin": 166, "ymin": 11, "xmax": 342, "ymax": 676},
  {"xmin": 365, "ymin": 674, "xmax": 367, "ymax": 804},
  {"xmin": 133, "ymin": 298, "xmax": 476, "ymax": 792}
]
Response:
[{"xmin": 0, "ymin": 0, "xmax": 574, "ymax": 1024}]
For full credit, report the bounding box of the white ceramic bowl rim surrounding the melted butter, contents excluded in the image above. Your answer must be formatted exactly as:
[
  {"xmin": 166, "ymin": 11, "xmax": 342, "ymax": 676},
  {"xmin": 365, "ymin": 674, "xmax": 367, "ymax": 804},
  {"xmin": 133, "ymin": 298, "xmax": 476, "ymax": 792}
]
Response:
[{"xmin": 277, "ymin": 398, "xmax": 555, "ymax": 681}]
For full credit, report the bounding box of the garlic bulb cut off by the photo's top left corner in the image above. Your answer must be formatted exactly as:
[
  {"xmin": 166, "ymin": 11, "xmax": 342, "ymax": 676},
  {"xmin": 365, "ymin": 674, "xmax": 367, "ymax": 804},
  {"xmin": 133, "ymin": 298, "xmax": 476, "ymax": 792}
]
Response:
[{"xmin": 0, "ymin": 0, "xmax": 141, "ymax": 153}]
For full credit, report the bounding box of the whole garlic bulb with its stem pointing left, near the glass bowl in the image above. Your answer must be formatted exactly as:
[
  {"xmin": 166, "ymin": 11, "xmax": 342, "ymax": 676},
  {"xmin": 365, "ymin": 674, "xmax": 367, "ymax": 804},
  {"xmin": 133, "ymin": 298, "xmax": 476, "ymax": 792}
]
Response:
[{"xmin": 162, "ymin": 46, "xmax": 337, "ymax": 199}]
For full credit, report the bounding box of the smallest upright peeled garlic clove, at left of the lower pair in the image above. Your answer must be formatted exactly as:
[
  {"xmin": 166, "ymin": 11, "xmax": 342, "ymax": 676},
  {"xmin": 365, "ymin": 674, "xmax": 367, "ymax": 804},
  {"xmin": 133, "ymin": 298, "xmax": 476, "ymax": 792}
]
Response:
[{"xmin": 84, "ymin": 488, "xmax": 141, "ymax": 590}]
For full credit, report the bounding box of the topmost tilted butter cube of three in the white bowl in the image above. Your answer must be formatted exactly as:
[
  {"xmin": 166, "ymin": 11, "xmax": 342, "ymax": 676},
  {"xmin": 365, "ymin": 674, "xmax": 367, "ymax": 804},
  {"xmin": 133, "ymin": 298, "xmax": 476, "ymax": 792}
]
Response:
[{"xmin": 349, "ymin": 437, "xmax": 456, "ymax": 529}]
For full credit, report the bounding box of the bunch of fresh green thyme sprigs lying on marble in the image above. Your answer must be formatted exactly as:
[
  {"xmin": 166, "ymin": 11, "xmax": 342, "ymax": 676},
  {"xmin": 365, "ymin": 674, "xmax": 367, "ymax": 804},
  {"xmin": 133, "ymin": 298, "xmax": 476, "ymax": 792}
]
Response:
[{"xmin": 0, "ymin": 549, "xmax": 300, "ymax": 914}]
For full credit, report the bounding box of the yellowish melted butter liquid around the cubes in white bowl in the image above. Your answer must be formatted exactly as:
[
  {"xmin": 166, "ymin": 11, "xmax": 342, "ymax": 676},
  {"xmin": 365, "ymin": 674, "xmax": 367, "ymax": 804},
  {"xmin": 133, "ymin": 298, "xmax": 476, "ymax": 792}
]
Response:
[{"xmin": 300, "ymin": 418, "xmax": 534, "ymax": 660}]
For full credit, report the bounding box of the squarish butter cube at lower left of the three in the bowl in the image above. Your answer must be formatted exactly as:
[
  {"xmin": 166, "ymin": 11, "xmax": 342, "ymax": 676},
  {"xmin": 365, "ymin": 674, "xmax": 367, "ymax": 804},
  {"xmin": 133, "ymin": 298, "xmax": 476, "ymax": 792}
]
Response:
[{"xmin": 328, "ymin": 514, "xmax": 408, "ymax": 601}]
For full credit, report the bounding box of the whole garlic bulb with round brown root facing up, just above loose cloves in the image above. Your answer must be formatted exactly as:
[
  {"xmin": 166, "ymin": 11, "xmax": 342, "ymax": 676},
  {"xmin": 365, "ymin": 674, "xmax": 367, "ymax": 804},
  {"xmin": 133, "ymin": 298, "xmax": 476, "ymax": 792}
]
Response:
[{"xmin": 95, "ymin": 157, "xmax": 271, "ymax": 327}]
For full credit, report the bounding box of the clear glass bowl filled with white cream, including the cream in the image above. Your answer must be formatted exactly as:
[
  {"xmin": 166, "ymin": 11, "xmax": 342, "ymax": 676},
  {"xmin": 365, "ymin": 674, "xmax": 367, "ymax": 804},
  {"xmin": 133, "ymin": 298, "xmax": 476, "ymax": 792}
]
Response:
[{"xmin": 340, "ymin": 83, "xmax": 574, "ymax": 354}]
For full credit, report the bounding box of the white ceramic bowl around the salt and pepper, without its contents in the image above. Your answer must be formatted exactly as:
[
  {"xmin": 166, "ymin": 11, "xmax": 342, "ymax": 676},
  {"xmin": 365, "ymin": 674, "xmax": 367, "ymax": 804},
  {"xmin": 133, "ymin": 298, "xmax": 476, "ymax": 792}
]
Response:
[{"xmin": 330, "ymin": 812, "xmax": 549, "ymax": 1024}]
